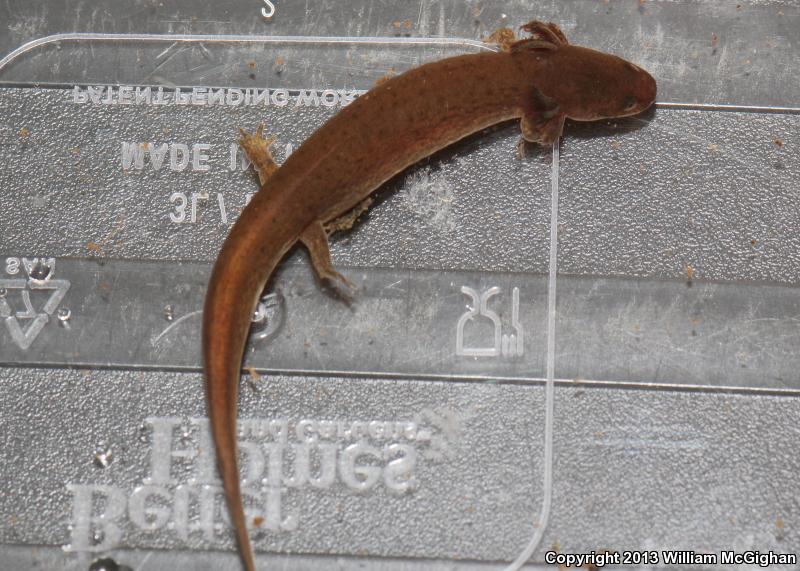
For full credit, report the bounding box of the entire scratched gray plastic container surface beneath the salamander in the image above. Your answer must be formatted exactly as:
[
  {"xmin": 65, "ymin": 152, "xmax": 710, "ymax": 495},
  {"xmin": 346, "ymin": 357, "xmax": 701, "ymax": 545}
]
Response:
[{"xmin": 0, "ymin": 0, "xmax": 800, "ymax": 571}]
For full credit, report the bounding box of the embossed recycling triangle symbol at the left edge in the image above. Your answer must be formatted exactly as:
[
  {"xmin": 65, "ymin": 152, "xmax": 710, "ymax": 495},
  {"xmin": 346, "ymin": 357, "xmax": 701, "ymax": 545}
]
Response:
[{"xmin": 0, "ymin": 279, "xmax": 70, "ymax": 351}]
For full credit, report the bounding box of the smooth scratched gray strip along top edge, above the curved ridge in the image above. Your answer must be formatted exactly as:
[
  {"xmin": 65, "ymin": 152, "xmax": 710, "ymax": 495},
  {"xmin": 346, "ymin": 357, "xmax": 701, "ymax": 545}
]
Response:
[{"xmin": 0, "ymin": 0, "xmax": 800, "ymax": 107}]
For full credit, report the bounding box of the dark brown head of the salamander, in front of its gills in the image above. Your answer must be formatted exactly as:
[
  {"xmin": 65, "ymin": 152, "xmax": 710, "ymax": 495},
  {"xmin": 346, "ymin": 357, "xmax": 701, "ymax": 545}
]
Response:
[{"xmin": 543, "ymin": 46, "xmax": 656, "ymax": 121}]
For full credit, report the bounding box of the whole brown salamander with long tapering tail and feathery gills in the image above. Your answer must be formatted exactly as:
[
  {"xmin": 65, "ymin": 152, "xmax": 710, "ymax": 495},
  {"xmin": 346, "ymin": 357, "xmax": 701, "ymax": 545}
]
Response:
[{"xmin": 203, "ymin": 22, "xmax": 656, "ymax": 571}]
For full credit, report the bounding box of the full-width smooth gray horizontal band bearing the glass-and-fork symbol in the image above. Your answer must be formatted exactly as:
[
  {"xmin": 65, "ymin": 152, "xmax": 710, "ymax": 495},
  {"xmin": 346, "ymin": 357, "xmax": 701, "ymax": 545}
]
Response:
[{"xmin": 7, "ymin": 258, "xmax": 800, "ymax": 392}]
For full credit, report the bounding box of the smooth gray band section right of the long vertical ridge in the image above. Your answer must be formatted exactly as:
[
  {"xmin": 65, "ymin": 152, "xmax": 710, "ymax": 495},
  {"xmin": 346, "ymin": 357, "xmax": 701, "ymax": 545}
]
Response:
[{"xmin": 556, "ymin": 277, "xmax": 800, "ymax": 393}]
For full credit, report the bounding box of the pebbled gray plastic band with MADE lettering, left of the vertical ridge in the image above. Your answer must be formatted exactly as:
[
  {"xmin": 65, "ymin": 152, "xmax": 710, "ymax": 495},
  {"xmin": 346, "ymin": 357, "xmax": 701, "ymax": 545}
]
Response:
[{"xmin": 0, "ymin": 88, "xmax": 550, "ymax": 271}]
